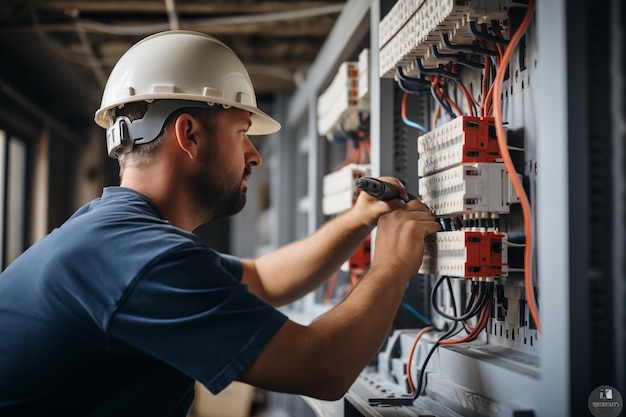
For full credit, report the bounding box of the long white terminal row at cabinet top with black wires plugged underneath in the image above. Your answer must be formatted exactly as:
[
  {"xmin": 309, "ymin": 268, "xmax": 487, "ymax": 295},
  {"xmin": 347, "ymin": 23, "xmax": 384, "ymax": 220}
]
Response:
[{"xmin": 379, "ymin": 0, "xmax": 512, "ymax": 78}]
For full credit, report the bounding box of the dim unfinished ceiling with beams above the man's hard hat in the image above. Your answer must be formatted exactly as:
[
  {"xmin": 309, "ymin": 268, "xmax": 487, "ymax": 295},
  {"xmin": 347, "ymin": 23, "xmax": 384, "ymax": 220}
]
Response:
[{"xmin": 0, "ymin": 0, "xmax": 345, "ymax": 136}]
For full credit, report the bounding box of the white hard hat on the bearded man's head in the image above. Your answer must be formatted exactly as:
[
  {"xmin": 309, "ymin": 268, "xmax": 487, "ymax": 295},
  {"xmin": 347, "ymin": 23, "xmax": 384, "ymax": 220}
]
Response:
[{"xmin": 95, "ymin": 30, "xmax": 280, "ymax": 155}]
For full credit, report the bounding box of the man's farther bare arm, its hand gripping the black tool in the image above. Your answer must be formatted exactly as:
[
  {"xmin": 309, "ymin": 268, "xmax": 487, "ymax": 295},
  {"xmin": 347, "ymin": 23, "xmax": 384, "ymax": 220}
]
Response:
[{"xmin": 242, "ymin": 177, "xmax": 408, "ymax": 306}]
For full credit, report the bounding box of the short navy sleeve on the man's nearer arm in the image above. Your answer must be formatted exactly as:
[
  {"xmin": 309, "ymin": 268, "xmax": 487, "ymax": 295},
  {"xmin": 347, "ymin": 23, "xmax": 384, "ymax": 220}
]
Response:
[{"xmin": 108, "ymin": 246, "xmax": 287, "ymax": 393}]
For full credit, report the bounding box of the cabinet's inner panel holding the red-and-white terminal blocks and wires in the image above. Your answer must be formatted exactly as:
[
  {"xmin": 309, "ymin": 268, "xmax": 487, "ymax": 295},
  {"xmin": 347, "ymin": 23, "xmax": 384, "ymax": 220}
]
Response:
[{"xmin": 353, "ymin": 0, "xmax": 541, "ymax": 416}]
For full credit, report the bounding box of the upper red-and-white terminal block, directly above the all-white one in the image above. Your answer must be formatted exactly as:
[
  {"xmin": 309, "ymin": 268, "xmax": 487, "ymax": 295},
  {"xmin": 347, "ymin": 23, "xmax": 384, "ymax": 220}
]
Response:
[{"xmin": 417, "ymin": 116, "xmax": 502, "ymax": 177}]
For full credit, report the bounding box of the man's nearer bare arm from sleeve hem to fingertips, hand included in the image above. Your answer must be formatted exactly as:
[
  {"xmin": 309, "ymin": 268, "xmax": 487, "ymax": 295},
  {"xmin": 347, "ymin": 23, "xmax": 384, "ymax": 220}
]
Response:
[{"xmin": 239, "ymin": 201, "xmax": 440, "ymax": 399}]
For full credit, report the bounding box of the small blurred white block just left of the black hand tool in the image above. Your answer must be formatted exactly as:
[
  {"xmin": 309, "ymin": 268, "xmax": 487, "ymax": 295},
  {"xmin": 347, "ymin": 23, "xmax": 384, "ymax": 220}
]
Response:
[{"xmin": 322, "ymin": 164, "xmax": 370, "ymax": 216}]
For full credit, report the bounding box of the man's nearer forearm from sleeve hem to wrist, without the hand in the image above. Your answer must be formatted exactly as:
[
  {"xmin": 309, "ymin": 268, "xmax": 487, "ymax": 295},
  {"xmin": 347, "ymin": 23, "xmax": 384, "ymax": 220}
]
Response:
[{"xmin": 240, "ymin": 264, "xmax": 409, "ymax": 400}]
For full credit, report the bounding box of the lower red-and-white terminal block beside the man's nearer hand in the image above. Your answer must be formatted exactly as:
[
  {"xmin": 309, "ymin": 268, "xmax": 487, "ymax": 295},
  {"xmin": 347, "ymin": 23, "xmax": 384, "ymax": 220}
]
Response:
[{"xmin": 419, "ymin": 230, "xmax": 508, "ymax": 280}]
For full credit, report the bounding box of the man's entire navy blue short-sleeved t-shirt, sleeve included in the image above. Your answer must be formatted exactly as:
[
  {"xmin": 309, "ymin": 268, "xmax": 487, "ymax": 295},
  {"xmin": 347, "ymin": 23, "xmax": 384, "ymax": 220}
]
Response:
[{"xmin": 0, "ymin": 187, "xmax": 286, "ymax": 416}]
